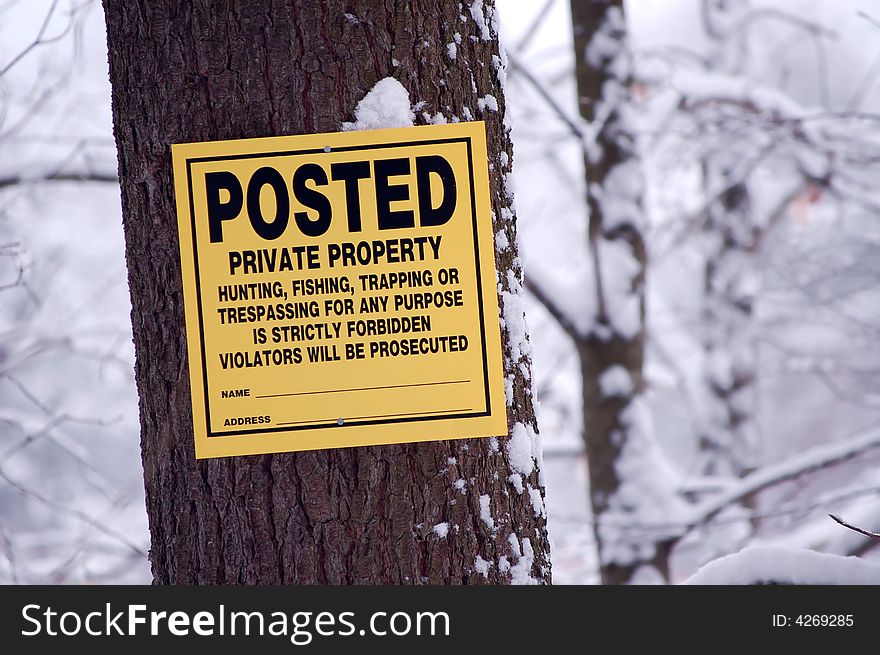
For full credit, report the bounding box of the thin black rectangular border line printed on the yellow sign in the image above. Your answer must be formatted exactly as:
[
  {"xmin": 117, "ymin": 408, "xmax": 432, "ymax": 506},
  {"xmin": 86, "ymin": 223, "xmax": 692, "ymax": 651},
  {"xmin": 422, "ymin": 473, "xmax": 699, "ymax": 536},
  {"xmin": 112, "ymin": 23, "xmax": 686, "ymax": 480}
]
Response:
[{"xmin": 184, "ymin": 136, "xmax": 492, "ymax": 439}]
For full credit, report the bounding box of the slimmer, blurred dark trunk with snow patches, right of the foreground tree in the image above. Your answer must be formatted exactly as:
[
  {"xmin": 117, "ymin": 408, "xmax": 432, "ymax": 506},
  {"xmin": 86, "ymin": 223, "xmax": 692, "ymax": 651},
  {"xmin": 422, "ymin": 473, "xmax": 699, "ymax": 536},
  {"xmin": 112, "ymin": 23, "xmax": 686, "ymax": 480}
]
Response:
[{"xmin": 571, "ymin": 0, "xmax": 671, "ymax": 584}]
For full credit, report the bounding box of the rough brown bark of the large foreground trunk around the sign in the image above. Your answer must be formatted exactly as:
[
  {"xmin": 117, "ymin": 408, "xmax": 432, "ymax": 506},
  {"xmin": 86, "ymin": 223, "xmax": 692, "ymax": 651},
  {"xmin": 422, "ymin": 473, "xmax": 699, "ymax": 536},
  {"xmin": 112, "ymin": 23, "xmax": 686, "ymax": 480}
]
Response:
[{"xmin": 104, "ymin": 0, "xmax": 550, "ymax": 584}]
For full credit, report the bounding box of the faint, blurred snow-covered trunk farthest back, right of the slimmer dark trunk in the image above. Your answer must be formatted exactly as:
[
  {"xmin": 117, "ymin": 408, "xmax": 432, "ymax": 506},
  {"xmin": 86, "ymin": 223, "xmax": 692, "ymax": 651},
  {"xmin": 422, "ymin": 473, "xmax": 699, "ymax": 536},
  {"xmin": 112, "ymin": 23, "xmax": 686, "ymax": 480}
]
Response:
[{"xmin": 699, "ymin": 0, "xmax": 761, "ymax": 477}]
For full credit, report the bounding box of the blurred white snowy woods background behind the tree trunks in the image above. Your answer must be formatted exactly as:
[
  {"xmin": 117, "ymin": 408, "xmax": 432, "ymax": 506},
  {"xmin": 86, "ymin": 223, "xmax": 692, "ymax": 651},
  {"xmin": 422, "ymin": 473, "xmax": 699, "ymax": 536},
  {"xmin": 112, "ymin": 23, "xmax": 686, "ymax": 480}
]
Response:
[{"xmin": 0, "ymin": 0, "xmax": 880, "ymax": 584}]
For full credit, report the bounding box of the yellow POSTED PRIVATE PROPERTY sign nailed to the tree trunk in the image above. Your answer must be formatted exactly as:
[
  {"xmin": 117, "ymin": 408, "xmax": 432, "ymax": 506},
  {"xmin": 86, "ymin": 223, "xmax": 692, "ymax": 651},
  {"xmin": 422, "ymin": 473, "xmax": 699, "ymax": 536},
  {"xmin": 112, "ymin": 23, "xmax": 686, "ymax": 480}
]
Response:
[{"xmin": 172, "ymin": 122, "xmax": 507, "ymax": 458}]
